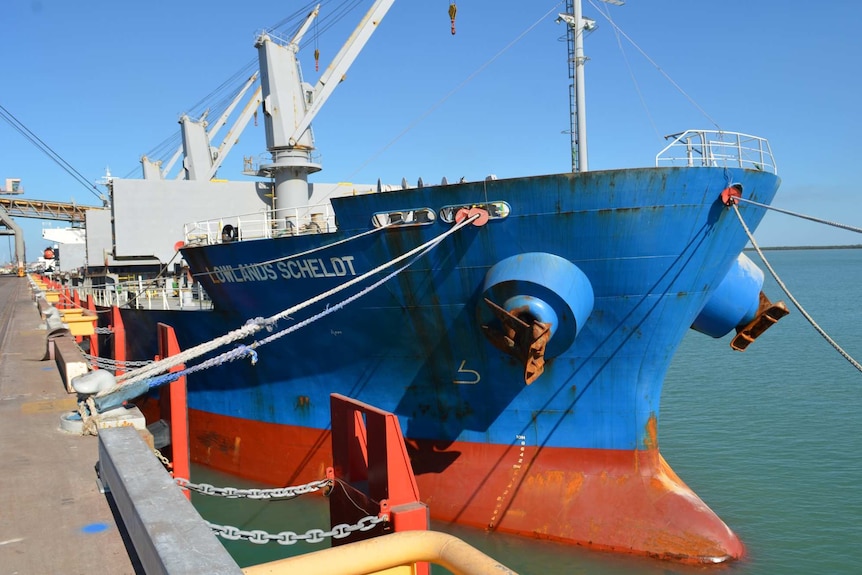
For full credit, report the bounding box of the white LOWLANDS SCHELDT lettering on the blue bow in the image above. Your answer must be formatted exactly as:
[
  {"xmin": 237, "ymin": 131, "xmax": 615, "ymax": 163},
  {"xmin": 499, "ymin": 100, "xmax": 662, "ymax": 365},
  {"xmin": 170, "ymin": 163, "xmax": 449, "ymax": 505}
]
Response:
[{"xmin": 211, "ymin": 256, "xmax": 356, "ymax": 283}]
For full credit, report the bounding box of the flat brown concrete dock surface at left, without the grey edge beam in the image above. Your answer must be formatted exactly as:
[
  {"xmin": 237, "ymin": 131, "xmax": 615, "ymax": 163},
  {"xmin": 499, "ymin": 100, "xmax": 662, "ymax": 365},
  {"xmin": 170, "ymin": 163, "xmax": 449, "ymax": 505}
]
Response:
[{"xmin": 0, "ymin": 276, "xmax": 142, "ymax": 575}]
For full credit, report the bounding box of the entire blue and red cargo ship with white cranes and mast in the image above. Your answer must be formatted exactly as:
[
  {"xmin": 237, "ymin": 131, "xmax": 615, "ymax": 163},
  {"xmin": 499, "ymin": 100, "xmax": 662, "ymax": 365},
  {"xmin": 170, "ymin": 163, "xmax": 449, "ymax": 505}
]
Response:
[{"xmin": 76, "ymin": 0, "xmax": 780, "ymax": 563}]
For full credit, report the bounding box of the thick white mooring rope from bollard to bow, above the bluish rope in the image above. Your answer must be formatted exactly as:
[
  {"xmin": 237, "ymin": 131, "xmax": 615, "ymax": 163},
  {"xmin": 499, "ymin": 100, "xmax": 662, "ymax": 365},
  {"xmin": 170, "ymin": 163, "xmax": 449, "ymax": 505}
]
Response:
[{"xmin": 102, "ymin": 215, "xmax": 479, "ymax": 397}]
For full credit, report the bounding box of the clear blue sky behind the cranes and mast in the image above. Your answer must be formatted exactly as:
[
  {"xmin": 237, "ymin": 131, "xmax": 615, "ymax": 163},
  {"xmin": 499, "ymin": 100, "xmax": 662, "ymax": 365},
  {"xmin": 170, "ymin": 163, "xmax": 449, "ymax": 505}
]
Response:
[{"xmin": 0, "ymin": 0, "xmax": 862, "ymax": 260}]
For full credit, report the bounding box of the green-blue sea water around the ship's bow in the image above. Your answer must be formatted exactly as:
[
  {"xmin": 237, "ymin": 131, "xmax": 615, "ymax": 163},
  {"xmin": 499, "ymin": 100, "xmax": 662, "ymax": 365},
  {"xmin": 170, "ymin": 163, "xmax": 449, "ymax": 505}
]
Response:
[{"xmin": 192, "ymin": 249, "xmax": 862, "ymax": 575}]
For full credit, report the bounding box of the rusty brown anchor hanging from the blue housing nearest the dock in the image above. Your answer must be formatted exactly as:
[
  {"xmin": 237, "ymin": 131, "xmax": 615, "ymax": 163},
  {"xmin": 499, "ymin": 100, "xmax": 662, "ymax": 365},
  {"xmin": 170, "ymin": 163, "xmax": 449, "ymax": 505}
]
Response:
[{"xmin": 482, "ymin": 298, "xmax": 551, "ymax": 385}]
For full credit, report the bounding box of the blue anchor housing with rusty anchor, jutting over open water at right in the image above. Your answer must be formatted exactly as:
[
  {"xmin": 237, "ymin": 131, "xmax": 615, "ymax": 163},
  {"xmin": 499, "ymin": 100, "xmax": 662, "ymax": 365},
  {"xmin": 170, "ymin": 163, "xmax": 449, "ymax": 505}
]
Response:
[{"xmin": 691, "ymin": 254, "xmax": 790, "ymax": 351}]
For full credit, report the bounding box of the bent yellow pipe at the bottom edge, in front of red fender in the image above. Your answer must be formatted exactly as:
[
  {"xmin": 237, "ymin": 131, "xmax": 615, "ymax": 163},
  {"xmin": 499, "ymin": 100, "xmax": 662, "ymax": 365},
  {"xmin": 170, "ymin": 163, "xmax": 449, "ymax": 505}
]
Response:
[{"xmin": 242, "ymin": 531, "xmax": 517, "ymax": 575}]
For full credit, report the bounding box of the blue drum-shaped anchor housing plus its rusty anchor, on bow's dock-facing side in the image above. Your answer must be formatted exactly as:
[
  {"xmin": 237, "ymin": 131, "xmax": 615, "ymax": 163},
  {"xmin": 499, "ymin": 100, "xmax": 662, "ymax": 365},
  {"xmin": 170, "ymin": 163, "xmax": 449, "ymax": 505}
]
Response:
[{"xmin": 479, "ymin": 253, "xmax": 595, "ymax": 384}]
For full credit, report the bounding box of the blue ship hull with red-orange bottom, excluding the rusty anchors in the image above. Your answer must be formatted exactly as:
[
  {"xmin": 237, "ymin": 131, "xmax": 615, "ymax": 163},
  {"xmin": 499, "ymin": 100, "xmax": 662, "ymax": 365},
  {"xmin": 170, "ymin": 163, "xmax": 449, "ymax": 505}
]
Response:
[{"xmin": 113, "ymin": 167, "xmax": 779, "ymax": 561}]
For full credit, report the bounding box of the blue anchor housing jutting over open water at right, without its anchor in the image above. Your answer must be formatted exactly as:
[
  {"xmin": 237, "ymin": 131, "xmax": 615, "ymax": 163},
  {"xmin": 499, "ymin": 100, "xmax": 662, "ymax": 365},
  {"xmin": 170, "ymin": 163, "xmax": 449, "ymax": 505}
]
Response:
[{"xmin": 691, "ymin": 254, "xmax": 763, "ymax": 338}]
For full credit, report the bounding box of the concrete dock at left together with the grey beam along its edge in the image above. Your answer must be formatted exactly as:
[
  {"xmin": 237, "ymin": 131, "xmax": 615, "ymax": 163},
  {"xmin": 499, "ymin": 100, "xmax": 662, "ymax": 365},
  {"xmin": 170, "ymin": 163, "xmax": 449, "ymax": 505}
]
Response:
[{"xmin": 0, "ymin": 276, "xmax": 241, "ymax": 575}]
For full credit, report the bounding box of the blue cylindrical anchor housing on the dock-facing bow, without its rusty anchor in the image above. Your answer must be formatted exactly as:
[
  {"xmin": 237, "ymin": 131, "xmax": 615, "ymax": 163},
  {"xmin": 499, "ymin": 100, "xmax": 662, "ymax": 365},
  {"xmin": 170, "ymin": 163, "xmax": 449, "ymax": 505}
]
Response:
[{"xmin": 479, "ymin": 252, "xmax": 595, "ymax": 357}]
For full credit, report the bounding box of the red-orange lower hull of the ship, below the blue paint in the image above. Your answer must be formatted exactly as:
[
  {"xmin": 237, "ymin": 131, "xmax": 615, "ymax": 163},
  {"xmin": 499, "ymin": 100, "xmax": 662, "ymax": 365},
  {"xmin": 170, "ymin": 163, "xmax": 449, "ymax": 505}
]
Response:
[{"xmin": 189, "ymin": 410, "xmax": 745, "ymax": 563}]
